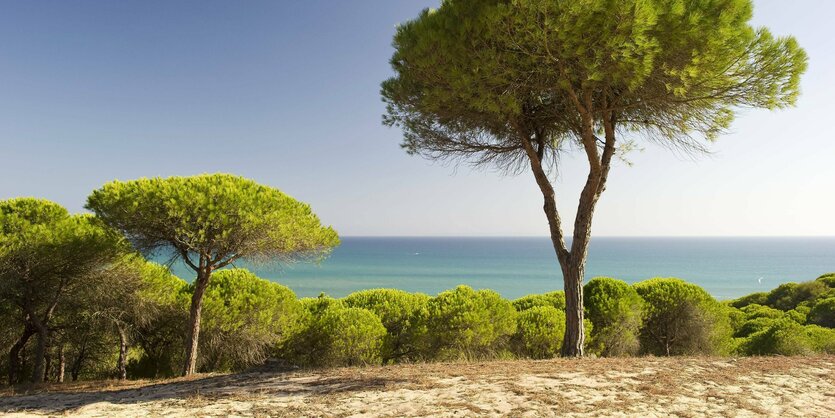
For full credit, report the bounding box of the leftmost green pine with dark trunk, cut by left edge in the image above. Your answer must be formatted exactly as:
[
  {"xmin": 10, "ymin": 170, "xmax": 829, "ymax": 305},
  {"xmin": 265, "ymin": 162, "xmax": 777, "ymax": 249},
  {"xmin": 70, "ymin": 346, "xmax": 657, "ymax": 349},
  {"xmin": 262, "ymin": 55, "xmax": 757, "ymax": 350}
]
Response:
[{"xmin": 0, "ymin": 198, "xmax": 128, "ymax": 383}]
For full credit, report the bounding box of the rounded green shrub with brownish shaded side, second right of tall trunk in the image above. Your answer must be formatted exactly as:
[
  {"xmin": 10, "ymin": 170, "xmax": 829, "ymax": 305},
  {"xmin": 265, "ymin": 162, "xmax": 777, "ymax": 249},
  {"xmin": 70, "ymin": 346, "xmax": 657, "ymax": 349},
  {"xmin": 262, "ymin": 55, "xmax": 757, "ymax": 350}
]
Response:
[{"xmin": 635, "ymin": 278, "xmax": 731, "ymax": 355}]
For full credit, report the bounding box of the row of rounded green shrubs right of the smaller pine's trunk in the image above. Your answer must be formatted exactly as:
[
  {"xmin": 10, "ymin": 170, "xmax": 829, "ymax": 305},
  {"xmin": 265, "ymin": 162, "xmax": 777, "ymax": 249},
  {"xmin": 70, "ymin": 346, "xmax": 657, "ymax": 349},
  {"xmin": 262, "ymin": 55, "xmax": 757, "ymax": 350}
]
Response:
[{"xmin": 152, "ymin": 269, "xmax": 835, "ymax": 370}]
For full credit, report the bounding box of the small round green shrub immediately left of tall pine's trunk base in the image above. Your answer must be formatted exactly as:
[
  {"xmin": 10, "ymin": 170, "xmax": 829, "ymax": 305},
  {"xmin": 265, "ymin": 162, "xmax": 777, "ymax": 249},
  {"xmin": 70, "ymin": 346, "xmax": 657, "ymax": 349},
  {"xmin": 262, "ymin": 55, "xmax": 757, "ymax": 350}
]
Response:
[{"xmin": 513, "ymin": 306, "xmax": 565, "ymax": 359}]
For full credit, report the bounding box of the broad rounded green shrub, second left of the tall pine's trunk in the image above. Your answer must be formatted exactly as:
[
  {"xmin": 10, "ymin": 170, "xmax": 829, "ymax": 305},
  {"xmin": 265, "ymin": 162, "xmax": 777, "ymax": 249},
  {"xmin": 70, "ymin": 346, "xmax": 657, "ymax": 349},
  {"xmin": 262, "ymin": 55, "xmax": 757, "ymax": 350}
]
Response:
[{"xmin": 421, "ymin": 286, "xmax": 516, "ymax": 360}]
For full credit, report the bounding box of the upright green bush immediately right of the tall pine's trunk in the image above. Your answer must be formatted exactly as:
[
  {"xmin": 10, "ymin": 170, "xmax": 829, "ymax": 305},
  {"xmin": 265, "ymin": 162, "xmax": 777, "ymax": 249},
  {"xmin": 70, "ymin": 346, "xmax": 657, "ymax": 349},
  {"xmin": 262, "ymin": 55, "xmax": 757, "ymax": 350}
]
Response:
[{"xmin": 583, "ymin": 277, "xmax": 644, "ymax": 356}]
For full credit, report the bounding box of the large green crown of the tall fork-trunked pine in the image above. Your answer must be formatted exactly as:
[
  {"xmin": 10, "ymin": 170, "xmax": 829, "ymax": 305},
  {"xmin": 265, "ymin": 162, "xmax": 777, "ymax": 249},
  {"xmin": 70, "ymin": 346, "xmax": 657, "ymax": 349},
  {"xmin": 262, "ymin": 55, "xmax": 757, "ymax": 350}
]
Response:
[{"xmin": 382, "ymin": 0, "xmax": 807, "ymax": 167}]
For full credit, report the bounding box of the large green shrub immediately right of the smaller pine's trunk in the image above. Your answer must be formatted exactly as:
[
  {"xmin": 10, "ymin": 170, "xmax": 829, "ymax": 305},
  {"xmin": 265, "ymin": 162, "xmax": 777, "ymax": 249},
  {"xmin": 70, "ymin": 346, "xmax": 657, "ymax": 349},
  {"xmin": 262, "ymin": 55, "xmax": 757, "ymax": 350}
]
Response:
[{"xmin": 200, "ymin": 269, "xmax": 302, "ymax": 371}]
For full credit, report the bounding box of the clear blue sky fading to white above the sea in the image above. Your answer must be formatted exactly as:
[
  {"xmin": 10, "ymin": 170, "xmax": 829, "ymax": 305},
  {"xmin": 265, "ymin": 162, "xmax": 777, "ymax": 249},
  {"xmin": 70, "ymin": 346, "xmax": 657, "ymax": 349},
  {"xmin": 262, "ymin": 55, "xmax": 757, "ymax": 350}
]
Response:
[{"xmin": 0, "ymin": 0, "xmax": 835, "ymax": 236}]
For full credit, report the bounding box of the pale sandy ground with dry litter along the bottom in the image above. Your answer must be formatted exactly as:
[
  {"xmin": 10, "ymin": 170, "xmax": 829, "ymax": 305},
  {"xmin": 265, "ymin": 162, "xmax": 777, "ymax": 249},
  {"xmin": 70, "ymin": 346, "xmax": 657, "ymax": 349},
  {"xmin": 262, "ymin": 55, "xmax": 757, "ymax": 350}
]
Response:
[{"xmin": 0, "ymin": 356, "xmax": 835, "ymax": 417}]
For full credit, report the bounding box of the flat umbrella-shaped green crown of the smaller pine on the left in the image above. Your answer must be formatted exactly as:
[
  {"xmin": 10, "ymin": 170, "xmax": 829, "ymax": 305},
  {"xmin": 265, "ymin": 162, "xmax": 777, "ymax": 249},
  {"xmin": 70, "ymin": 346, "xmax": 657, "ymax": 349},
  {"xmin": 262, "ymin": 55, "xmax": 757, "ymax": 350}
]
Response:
[{"xmin": 87, "ymin": 174, "xmax": 339, "ymax": 261}]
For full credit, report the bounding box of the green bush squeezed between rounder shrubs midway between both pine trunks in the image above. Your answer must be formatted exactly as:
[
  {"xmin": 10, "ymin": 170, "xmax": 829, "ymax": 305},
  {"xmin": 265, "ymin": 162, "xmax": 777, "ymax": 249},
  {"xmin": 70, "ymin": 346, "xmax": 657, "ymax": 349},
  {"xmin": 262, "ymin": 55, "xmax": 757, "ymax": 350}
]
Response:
[{"xmin": 343, "ymin": 289, "xmax": 429, "ymax": 363}]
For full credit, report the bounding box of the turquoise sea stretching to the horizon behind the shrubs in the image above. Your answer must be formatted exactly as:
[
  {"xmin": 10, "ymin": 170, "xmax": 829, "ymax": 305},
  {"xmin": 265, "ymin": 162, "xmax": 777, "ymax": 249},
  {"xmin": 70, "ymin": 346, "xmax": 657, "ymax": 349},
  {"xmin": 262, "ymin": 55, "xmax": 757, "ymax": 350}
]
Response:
[{"xmin": 163, "ymin": 237, "xmax": 835, "ymax": 299}]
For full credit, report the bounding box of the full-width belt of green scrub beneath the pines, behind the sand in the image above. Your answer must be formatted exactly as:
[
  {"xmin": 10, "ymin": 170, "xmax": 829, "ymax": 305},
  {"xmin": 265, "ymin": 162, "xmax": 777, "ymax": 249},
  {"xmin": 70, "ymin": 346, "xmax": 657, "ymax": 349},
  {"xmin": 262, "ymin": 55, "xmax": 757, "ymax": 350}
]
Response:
[{"xmin": 2, "ymin": 248, "xmax": 835, "ymax": 381}]
